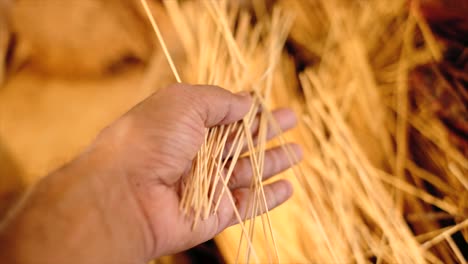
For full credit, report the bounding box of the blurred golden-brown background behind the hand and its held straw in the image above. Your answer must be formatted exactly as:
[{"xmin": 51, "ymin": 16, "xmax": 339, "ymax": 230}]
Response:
[{"xmin": 0, "ymin": 0, "xmax": 468, "ymax": 263}]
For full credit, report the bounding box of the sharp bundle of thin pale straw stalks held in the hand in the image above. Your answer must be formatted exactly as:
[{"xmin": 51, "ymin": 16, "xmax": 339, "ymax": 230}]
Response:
[{"xmin": 142, "ymin": 0, "xmax": 298, "ymax": 262}]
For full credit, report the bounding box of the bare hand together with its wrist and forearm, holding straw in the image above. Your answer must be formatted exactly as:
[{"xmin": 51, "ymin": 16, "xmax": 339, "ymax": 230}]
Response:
[{"xmin": 0, "ymin": 84, "xmax": 302, "ymax": 263}]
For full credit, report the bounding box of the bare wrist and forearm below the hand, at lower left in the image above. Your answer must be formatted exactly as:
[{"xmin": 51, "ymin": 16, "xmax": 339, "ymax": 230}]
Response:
[{"xmin": 0, "ymin": 125, "xmax": 153, "ymax": 263}]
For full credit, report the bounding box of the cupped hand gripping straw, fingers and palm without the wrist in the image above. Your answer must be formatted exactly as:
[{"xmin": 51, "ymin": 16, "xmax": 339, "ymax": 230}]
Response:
[{"xmin": 104, "ymin": 84, "xmax": 301, "ymax": 256}]
